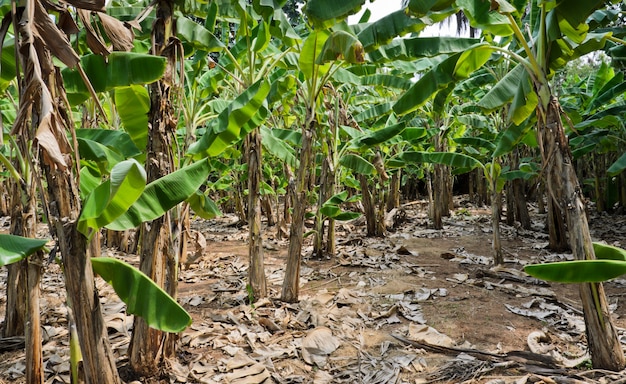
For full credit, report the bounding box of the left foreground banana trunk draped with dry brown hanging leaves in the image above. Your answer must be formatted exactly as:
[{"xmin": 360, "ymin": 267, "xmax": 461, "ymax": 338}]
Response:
[{"xmin": 12, "ymin": 0, "xmax": 121, "ymax": 384}]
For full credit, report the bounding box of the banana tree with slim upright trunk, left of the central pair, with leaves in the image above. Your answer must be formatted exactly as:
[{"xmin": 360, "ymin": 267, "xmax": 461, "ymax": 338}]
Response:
[{"xmin": 179, "ymin": 1, "xmax": 300, "ymax": 299}]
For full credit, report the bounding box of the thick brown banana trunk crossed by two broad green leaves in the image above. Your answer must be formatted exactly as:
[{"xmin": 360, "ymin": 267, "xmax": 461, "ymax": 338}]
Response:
[{"xmin": 128, "ymin": 0, "xmax": 178, "ymax": 377}]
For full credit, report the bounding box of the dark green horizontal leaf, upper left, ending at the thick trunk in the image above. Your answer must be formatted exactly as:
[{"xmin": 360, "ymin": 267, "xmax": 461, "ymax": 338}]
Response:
[{"xmin": 61, "ymin": 52, "xmax": 166, "ymax": 104}]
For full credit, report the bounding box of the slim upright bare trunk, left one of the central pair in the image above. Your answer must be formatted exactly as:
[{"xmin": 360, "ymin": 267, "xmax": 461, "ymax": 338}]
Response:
[{"xmin": 245, "ymin": 128, "xmax": 267, "ymax": 300}]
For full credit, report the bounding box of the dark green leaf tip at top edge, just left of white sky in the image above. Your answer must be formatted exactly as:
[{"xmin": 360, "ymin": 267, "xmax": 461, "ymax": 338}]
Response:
[{"xmin": 304, "ymin": 0, "xmax": 365, "ymax": 29}]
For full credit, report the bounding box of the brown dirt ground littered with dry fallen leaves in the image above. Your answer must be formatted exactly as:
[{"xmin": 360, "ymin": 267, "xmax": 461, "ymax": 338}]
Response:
[{"xmin": 0, "ymin": 198, "xmax": 626, "ymax": 384}]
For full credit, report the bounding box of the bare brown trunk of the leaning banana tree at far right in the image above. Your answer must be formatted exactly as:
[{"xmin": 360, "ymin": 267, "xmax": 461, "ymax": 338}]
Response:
[{"xmin": 538, "ymin": 97, "xmax": 626, "ymax": 371}]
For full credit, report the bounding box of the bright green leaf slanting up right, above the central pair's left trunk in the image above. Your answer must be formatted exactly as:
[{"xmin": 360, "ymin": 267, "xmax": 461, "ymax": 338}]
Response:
[{"xmin": 188, "ymin": 79, "xmax": 270, "ymax": 159}]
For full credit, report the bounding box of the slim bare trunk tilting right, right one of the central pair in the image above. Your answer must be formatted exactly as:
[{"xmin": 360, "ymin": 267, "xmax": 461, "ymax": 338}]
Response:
[{"xmin": 280, "ymin": 106, "xmax": 317, "ymax": 303}]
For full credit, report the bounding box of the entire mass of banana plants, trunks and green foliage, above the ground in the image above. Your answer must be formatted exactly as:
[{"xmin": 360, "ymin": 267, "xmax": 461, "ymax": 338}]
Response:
[{"xmin": 0, "ymin": 0, "xmax": 626, "ymax": 383}]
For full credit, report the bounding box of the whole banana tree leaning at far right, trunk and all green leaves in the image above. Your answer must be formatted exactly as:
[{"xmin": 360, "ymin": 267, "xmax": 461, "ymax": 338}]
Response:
[{"xmin": 310, "ymin": 0, "xmax": 626, "ymax": 370}]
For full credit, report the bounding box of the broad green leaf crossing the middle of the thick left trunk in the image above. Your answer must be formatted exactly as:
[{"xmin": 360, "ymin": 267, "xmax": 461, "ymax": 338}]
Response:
[{"xmin": 106, "ymin": 159, "xmax": 210, "ymax": 231}]
